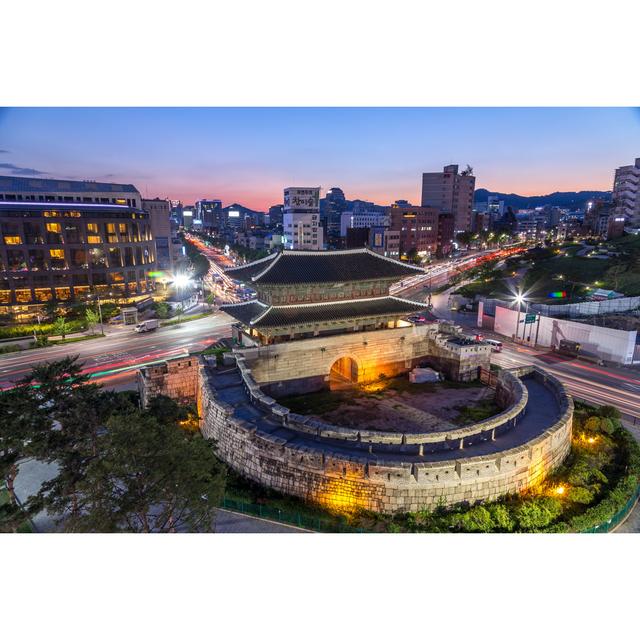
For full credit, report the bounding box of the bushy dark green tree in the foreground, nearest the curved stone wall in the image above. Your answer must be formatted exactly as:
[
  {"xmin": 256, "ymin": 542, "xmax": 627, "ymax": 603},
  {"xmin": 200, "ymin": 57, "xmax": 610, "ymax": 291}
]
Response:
[{"xmin": 72, "ymin": 409, "xmax": 225, "ymax": 533}]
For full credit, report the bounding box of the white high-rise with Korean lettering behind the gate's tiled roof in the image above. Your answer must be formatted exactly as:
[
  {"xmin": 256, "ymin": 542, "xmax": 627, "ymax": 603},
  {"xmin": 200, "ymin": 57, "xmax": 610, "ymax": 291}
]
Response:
[{"xmin": 282, "ymin": 187, "xmax": 324, "ymax": 251}]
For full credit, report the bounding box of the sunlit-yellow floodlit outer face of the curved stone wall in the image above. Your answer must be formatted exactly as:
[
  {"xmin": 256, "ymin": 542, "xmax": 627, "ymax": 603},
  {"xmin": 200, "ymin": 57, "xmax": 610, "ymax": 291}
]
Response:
[{"xmin": 199, "ymin": 365, "xmax": 573, "ymax": 513}]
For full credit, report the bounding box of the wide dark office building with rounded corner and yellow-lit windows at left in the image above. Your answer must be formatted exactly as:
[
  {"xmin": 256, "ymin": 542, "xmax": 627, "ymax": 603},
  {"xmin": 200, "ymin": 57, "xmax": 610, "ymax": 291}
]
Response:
[{"xmin": 0, "ymin": 177, "xmax": 156, "ymax": 319}]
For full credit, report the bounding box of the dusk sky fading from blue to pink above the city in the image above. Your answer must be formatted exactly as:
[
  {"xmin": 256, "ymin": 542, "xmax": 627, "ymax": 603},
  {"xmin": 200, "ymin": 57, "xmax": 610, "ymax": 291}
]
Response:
[{"xmin": 0, "ymin": 107, "xmax": 640, "ymax": 211}]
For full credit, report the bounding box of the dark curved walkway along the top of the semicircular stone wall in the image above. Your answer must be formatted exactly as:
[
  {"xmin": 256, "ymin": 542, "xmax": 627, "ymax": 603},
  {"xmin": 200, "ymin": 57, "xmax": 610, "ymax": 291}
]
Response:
[{"xmin": 209, "ymin": 368, "xmax": 560, "ymax": 463}]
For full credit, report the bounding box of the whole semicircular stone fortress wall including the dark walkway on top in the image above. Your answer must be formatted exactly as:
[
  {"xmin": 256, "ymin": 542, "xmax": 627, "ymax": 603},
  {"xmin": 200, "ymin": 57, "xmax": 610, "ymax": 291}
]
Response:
[{"xmin": 198, "ymin": 358, "xmax": 573, "ymax": 513}]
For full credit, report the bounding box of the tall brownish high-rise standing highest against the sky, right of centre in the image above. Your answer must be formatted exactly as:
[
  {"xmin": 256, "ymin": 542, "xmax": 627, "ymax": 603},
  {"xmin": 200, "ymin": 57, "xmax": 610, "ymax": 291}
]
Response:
[{"xmin": 422, "ymin": 164, "xmax": 476, "ymax": 232}]
